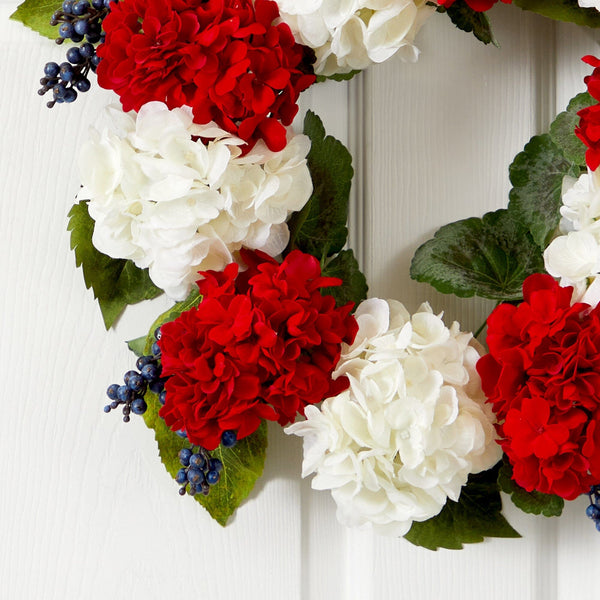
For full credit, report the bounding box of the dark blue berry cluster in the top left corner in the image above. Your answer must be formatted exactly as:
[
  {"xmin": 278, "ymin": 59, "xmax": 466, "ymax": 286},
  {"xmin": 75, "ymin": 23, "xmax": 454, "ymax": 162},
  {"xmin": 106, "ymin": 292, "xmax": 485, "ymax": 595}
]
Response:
[{"xmin": 38, "ymin": 0, "xmax": 111, "ymax": 108}]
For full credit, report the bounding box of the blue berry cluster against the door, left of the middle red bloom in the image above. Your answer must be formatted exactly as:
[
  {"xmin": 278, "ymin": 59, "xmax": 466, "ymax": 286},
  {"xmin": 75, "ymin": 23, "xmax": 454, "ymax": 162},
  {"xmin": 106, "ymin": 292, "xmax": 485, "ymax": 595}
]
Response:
[{"xmin": 104, "ymin": 328, "xmax": 166, "ymax": 423}]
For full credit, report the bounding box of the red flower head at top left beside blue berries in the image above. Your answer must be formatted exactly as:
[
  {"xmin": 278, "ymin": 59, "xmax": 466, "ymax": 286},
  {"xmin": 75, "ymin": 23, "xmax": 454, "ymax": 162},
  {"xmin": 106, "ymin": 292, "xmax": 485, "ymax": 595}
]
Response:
[{"xmin": 97, "ymin": 0, "xmax": 315, "ymax": 151}]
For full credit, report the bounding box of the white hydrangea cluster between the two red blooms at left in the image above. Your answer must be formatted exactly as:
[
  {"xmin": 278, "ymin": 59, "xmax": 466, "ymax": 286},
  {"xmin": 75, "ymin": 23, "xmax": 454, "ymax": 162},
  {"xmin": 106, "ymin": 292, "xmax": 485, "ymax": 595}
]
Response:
[{"xmin": 79, "ymin": 102, "xmax": 312, "ymax": 300}]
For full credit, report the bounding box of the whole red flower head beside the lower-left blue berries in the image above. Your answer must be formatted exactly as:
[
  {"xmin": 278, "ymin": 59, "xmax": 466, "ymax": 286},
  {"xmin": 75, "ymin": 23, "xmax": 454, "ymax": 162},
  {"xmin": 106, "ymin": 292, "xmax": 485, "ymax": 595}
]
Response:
[{"xmin": 159, "ymin": 250, "xmax": 358, "ymax": 450}]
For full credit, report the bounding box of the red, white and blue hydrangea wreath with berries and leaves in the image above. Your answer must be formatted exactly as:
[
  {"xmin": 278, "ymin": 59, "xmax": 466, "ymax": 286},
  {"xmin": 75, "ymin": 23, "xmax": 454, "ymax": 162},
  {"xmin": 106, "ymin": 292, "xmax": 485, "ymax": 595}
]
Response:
[{"xmin": 9, "ymin": 0, "xmax": 600, "ymax": 549}]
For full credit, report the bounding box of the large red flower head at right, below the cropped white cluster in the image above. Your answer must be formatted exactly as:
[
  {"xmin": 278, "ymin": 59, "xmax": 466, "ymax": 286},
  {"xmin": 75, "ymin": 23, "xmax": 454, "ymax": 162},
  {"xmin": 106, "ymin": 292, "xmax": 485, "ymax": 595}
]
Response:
[{"xmin": 477, "ymin": 275, "xmax": 600, "ymax": 500}]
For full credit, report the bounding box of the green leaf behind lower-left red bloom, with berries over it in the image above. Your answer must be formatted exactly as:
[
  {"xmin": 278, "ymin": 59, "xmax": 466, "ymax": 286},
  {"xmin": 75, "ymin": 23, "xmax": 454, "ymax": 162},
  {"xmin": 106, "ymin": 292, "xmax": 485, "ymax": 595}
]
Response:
[{"xmin": 143, "ymin": 296, "xmax": 267, "ymax": 526}]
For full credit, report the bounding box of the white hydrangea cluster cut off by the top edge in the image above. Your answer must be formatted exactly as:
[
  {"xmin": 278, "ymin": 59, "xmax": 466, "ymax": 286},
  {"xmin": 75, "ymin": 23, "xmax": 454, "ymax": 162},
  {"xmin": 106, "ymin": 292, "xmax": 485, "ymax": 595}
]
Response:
[{"xmin": 277, "ymin": 0, "xmax": 435, "ymax": 75}]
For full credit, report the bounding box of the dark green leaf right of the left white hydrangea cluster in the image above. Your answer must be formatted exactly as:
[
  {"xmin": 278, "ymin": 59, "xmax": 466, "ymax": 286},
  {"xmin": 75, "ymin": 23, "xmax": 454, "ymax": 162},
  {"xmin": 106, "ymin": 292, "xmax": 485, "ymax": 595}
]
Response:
[{"xmin": 288, "ymin": 111, "xmax": 353, "ymax": 259}]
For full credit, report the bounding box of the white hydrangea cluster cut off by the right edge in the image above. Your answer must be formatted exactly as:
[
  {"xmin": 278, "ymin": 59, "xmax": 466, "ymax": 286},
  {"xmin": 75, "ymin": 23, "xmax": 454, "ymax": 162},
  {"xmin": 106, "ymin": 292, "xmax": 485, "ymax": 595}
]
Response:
[{"xmin": 544, "ymin": 169, "xmax": 600, "ymax": 306}]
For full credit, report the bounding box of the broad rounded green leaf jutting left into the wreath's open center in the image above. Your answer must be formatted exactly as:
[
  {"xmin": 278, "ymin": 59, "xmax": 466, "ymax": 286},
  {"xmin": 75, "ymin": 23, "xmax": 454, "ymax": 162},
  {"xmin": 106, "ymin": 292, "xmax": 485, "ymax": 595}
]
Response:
[{"xmin": 410, "ymin": 209, "xmax": 544, "ymax": 300}]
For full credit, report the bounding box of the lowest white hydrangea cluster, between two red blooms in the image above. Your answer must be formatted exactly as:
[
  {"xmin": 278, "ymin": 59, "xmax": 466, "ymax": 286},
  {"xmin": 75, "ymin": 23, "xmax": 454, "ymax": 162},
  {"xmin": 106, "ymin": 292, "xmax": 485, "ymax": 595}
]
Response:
[{"xmin": 286, "ymin": 298, "xmax": 502, "ymax": 535}]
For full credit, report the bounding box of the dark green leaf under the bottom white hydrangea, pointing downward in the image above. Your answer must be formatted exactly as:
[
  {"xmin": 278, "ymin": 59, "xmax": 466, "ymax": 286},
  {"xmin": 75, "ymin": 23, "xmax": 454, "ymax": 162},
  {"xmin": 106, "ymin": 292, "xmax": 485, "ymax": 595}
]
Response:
[{"xmin": 404, "ymin": 463, "xmax": 521, "ymax": 550}]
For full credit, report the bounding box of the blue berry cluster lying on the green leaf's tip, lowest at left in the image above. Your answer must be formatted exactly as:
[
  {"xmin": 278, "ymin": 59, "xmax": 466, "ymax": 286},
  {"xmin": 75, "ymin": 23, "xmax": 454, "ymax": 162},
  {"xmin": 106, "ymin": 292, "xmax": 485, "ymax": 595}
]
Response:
[{"xmin": 175, "ymin": 430, "xmax": 237, "ymax": 496}]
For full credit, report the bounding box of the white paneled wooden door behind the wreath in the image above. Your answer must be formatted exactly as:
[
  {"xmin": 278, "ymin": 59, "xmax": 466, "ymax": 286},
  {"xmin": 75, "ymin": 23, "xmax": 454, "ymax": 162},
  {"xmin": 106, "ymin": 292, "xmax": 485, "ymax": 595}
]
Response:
[{"xmin": 0, "ymin": 0, "xmax": 600, "ymax": 600}]
